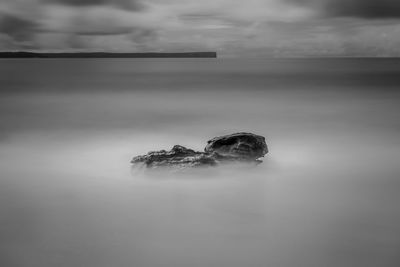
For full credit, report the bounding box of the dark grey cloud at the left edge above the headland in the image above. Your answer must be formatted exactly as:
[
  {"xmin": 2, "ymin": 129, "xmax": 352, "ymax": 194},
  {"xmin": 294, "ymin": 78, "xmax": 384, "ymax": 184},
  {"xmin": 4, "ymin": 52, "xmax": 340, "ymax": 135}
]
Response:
[{"xmin": 0, "ymin": 13, "xmax": 38, "ymax": 41}]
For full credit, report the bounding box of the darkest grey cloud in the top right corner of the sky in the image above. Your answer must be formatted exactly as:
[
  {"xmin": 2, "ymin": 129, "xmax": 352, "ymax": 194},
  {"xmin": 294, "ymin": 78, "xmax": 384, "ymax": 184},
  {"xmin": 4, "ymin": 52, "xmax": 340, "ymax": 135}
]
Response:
[{"xmin": 287, "ymin": 0, "xmax": 400, "ymax": 19}]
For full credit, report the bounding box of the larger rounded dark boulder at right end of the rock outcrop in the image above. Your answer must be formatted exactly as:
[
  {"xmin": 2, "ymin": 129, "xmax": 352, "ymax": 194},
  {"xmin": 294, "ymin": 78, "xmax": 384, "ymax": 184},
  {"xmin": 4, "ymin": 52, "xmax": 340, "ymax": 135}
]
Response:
[{"xmin": 204, "ymin": 133, "xmax": 268, "ymax": 161}]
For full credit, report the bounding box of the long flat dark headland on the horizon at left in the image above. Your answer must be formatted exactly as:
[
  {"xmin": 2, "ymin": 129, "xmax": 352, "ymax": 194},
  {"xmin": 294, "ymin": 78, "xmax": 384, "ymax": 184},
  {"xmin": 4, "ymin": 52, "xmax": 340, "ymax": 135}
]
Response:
[{"xmin": 0, "ymin": 51, "xmax": 217, "ymax": 58}]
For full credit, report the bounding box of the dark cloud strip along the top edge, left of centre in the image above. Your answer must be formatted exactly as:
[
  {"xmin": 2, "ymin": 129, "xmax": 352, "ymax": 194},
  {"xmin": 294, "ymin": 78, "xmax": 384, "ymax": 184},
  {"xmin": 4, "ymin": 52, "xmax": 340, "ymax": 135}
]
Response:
[{"xmin": 44, "ymin": 0, "xmax": 145, "ymax": 11}]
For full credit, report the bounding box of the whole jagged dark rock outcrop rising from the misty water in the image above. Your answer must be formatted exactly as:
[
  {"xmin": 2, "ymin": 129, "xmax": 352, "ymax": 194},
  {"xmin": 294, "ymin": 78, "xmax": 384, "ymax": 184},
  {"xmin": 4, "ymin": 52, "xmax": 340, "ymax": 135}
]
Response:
[{"xmin": 131, "ymin": 133, "xmax": 268, "ymax": 169}]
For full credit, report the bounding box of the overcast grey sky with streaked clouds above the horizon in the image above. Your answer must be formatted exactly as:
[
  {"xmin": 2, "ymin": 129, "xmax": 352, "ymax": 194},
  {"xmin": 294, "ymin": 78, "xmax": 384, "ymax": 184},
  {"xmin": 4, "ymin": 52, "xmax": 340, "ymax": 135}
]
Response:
[{"xmin": 0, "ymin": 0, "xmax": 400, "ymax": 57}]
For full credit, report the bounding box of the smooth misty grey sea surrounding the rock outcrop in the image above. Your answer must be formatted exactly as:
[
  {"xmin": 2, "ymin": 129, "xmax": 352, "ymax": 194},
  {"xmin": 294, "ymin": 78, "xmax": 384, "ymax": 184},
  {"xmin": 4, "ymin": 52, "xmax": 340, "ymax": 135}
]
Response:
[{"xmin": 0, "ymin": 59, "xmax": 400, "ymax": 267}]
